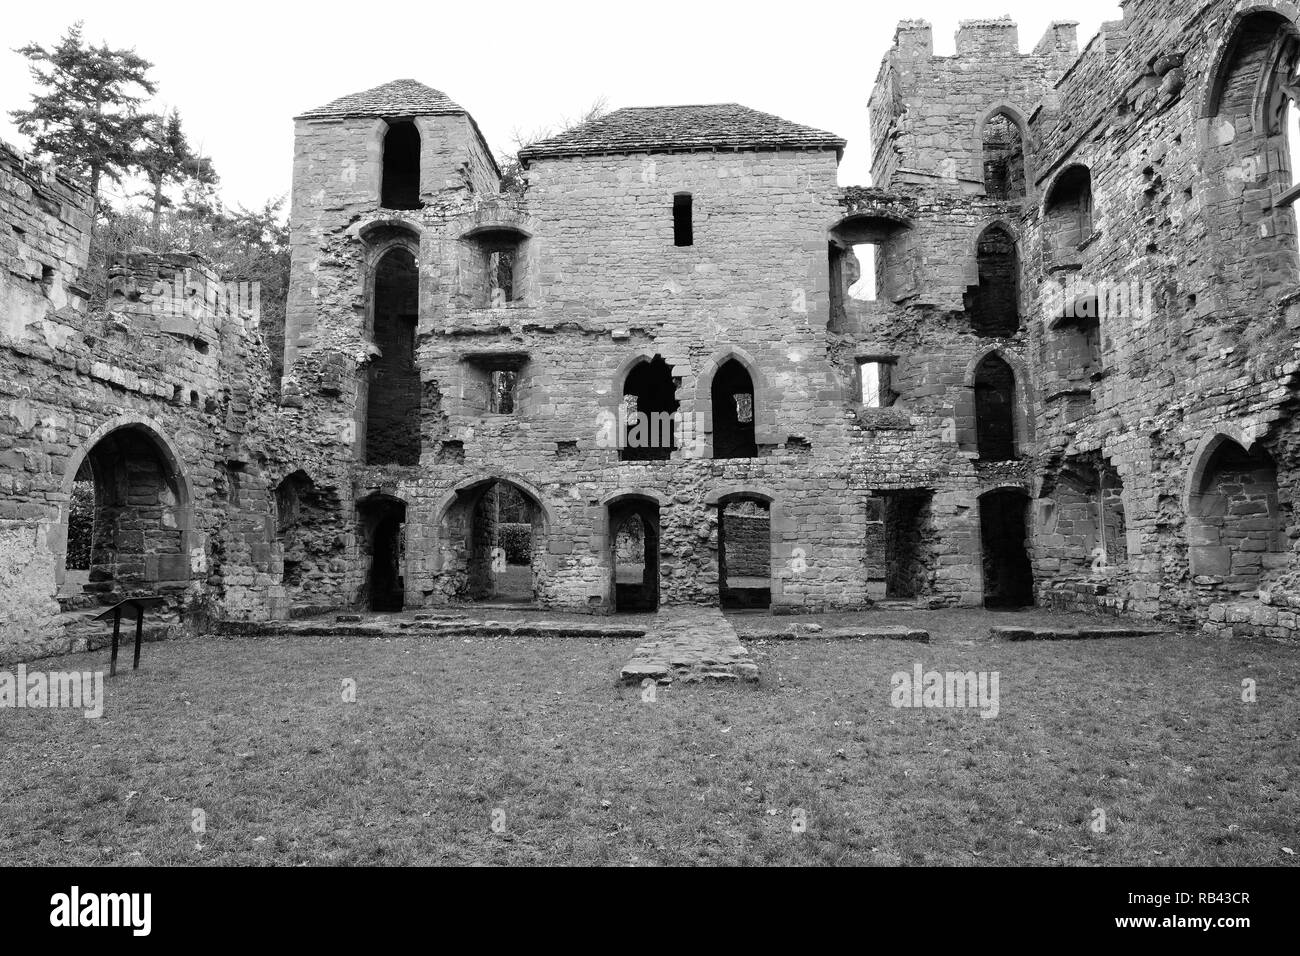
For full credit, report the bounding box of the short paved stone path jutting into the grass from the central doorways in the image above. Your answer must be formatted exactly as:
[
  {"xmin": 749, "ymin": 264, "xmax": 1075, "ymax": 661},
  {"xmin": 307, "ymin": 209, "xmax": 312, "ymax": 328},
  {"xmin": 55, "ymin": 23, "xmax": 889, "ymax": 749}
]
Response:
[{"xmin": 619, "ymin": 607, "xmax": 758, "ymax": 684}]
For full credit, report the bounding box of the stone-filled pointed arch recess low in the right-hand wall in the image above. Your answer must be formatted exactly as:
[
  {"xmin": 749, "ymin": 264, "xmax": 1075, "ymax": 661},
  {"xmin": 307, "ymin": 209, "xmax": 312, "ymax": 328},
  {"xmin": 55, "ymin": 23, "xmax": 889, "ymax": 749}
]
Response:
[{"xmin": 1187, "ymin": 438, "xmax": 1288, "ymax": 596}]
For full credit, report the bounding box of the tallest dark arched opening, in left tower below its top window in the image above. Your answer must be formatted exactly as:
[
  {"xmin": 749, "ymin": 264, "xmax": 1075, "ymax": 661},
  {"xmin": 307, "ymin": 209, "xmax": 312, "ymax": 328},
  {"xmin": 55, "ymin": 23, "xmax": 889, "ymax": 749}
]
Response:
[{"xmin": 365, "ymin": 247, "xmax": 420, "ymax": 464}]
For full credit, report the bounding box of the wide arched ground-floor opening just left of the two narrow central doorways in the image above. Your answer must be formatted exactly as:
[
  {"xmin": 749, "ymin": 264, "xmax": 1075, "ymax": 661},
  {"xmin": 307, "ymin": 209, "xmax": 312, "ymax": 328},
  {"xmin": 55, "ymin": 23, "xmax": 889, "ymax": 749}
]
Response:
[{"xmin": 456, "ymin": 480, "xmax": 546, "ymax": 605}]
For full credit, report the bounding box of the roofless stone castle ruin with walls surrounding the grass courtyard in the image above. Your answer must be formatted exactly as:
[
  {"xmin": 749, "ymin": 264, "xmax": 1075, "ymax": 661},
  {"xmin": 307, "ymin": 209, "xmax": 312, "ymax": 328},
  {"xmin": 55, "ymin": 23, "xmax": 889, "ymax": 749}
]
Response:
[{"xmin": 0, "ymin": 0, "xmax": 1300, "ymax": 659}]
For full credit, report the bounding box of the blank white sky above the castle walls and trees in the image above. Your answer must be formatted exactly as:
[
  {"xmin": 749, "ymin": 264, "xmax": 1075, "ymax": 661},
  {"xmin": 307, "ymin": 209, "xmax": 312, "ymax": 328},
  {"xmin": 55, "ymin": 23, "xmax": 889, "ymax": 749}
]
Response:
[{"xmin": 0, "ymin": 0, "xmax": 1122, "ymax": 207}]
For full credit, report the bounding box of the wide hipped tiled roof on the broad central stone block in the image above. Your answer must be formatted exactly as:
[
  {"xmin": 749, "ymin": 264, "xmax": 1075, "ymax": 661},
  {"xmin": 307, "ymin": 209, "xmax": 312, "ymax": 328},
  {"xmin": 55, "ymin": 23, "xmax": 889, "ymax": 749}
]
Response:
[{"xmin": 519, "ymin": 103, "xmax": 845, "ymax": 164}]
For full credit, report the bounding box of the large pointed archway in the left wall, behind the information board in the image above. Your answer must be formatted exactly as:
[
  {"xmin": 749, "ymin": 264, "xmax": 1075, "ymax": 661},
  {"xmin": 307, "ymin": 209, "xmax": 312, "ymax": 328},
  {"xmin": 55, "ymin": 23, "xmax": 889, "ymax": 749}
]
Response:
[{"xmin": 62, "ymin": 427, "xmax": 191, "ymax": 605}]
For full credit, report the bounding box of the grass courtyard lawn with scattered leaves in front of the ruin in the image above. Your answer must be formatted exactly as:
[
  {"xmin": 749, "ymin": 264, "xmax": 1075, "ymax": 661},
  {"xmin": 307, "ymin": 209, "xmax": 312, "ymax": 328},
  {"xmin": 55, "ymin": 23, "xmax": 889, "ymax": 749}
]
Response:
[{"xmin": 0, "ymin": 614, "xmax": 1300, "ymax": 866}]
